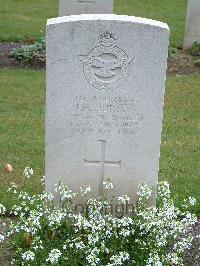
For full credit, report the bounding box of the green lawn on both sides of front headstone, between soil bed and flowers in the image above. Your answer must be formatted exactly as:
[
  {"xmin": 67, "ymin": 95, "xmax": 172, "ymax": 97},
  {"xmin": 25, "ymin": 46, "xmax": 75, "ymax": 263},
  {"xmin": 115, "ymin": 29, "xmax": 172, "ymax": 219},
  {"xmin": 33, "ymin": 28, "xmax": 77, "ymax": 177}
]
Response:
[{"xmin": 0, "ymin": 69, "xmax": 200, "ymax": 215}]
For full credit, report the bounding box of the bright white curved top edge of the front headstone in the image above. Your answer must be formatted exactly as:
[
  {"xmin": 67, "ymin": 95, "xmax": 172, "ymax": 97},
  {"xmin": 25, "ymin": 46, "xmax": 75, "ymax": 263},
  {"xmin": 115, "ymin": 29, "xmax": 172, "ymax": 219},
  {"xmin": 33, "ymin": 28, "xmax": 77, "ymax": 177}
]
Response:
[{"xmin": 47, "ymin": 14, "xmax": 169, "ymax": 30}]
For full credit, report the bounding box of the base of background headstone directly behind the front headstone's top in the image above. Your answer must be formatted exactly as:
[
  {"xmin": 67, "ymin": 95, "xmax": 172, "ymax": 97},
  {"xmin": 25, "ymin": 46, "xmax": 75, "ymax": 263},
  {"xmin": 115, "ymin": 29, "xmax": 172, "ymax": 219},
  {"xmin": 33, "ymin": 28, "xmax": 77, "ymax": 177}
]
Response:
[{"xmin": 59, "ymin": 0, "xmax": 114, "ymax": 17}]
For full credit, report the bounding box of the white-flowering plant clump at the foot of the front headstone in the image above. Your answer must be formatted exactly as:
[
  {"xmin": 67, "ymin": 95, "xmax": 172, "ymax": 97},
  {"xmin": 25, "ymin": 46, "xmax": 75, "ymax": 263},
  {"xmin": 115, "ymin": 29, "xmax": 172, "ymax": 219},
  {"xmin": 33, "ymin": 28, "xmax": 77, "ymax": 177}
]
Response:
[{"xmin": 0, "ymin": 168, "xmax": 197, "ymax": 266}]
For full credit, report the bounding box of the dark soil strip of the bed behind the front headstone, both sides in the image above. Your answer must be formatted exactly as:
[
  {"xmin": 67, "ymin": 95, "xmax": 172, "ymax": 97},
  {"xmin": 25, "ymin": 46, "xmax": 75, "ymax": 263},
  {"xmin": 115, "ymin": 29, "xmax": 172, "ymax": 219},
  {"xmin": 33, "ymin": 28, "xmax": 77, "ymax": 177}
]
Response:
[{"xmin": 0, "ymin": 43, "xmax": 200, "ymax": 76}]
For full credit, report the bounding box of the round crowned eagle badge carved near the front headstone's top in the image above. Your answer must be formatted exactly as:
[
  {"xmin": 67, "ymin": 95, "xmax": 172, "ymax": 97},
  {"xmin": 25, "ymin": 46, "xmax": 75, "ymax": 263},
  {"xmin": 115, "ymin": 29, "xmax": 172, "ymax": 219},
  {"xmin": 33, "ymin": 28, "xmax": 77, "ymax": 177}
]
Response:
[{"xmin": 78, "ymin": 32, "xmax": 132, "ymax": 90}]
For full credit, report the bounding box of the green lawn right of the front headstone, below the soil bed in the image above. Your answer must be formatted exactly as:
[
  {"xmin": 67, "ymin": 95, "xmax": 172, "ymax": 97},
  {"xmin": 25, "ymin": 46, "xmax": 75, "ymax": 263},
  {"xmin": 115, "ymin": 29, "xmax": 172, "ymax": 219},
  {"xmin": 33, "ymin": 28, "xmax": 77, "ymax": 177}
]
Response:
[{"xmin": 159, "ymin": 75, "xmax": 200, "ymax": 216}]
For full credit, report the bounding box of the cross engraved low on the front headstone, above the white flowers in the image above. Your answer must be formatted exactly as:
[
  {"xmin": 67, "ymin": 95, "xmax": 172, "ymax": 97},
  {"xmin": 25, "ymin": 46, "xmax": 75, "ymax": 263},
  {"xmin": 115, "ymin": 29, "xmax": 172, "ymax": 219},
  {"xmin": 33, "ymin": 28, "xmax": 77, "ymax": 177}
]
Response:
[{"xmin": 84, "ymin": 140, "xmax": 121, "ymax": 195}]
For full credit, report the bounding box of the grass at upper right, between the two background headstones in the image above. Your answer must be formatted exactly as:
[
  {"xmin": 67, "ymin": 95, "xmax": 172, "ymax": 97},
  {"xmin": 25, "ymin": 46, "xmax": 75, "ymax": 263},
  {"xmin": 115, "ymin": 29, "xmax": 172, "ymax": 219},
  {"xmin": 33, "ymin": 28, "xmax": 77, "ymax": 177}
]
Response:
[{"xmin": 115, "ymin": 0, "xmax": 187, "ymax": 48}]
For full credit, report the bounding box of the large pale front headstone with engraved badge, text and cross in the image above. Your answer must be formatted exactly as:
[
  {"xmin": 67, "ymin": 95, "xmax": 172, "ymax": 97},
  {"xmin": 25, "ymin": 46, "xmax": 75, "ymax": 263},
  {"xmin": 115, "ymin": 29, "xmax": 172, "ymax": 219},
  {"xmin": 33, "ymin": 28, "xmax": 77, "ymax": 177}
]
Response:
[{"xmin": 46, "ymin": 15, "xmax": 169, "ymax": 204}]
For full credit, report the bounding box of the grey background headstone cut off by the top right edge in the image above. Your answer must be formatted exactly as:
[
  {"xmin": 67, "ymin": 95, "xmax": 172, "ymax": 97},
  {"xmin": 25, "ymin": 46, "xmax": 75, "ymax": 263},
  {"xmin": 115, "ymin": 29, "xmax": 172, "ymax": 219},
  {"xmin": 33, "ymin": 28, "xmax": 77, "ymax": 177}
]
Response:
[{"xmin": 183, "ymin": 0, "xmax": 200, "ymax": 50}]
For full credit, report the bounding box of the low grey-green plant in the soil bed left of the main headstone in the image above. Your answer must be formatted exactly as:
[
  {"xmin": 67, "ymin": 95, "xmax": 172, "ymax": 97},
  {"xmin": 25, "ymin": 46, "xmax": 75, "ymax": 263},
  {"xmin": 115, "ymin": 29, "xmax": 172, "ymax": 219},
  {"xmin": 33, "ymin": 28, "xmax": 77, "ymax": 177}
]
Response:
[{"xmin": 10, "ymin": 38, "xmax": 46, "ymax": 63}]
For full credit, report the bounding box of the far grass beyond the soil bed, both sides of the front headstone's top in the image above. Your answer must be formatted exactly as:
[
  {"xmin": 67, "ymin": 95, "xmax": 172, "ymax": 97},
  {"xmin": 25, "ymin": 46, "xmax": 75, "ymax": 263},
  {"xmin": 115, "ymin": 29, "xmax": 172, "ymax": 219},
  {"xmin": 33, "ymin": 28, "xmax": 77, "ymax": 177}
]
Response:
[{"xmin": 0, "ymin": 0, "xmax": 187, "ymax": 47}]
